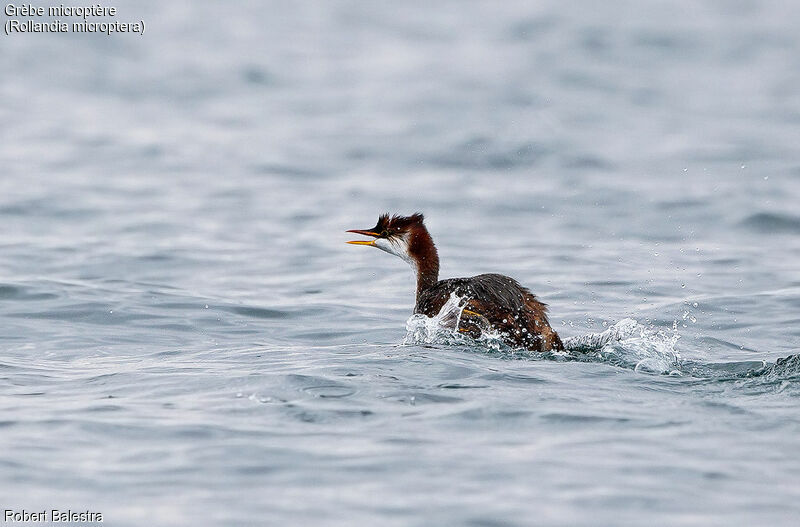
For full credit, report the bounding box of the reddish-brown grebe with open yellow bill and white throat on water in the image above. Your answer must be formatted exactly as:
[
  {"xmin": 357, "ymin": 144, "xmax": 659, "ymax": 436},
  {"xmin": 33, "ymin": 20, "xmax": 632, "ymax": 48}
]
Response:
[{"xmin": 347, "ymin": 213, "xmax": 564, "ymax": 351}]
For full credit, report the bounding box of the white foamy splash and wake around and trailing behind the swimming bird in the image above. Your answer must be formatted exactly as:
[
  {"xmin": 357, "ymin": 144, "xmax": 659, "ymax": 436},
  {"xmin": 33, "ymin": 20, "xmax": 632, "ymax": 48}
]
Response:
[{"xmin": 403, "ymin": 294, "xmax": 800, "ymax": 382}]
